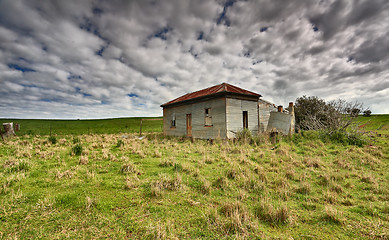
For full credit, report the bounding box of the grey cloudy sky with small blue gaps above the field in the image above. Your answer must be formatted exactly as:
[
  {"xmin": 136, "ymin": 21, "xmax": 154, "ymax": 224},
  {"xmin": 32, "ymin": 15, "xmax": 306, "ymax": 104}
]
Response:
[{"xmin": 0, "ymin": 0, "xmax": 389, "ymax": 119}]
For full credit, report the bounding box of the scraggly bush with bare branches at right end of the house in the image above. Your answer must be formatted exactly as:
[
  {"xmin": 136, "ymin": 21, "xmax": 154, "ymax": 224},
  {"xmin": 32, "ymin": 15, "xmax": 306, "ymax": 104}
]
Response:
[{"xmin": 295, "ymin": 96, "xmax": 362, "ymax": 133}]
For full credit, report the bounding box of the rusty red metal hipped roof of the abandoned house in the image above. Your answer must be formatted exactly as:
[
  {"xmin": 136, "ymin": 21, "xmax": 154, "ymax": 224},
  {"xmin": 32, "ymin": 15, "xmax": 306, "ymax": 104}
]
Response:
[{"xmin": 161, "ymin": 83, "xmax": 261, "ymax": 107}]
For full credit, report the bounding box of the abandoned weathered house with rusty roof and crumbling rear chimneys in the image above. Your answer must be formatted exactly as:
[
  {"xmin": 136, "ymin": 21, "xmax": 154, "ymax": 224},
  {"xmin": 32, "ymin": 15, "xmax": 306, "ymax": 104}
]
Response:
[{"xmin": 161, "ymin": 83, "xmax": 294, "ymax": 139}]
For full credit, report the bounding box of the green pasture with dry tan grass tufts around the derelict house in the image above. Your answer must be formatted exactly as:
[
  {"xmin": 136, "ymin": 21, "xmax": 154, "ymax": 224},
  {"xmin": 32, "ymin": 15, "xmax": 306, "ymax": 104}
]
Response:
[{"xmin": 0, "ymin": 115, "xmax": 389, "ymax": 239}]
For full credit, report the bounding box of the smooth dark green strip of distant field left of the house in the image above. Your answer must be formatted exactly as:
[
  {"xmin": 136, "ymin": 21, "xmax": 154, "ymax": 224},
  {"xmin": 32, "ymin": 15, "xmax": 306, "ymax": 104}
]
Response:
[{"xmin": 0, "ymin": 117, "xmax": 162, "ymax": 136}]
